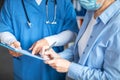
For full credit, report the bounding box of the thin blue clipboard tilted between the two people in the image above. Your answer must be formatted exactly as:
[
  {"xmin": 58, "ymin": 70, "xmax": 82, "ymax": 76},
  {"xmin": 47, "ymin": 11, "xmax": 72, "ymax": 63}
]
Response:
[{"xmin": 0, "ymin": 42, "xmax": 45, "ymax": 60}]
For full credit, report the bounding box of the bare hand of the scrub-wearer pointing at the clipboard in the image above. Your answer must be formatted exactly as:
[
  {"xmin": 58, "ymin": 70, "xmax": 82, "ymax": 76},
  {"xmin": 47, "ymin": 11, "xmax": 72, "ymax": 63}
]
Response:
[{"xmin": 29, "ymin": 39, "xmax": 49, "ymax": 54}]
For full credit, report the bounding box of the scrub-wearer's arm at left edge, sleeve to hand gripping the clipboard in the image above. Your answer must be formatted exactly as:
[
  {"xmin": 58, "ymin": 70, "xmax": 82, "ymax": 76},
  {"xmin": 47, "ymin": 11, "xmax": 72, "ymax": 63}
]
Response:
[{"xmin": 0, "ymin": 0, "xmax": 21, "ymax": 57}]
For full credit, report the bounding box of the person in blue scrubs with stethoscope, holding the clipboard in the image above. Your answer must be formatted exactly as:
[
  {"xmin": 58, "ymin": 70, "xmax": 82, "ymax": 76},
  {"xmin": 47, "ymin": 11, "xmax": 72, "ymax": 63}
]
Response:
[{"xmin": 0, "ymin": 0, "xmax": 78, "ymax": 80}]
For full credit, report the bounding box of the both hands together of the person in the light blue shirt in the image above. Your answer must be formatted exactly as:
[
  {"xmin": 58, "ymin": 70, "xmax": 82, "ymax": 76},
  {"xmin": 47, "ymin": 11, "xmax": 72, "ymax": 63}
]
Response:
[{"xmin": 42, "ymin": 46, "xmax": 71, "ymax": 72}]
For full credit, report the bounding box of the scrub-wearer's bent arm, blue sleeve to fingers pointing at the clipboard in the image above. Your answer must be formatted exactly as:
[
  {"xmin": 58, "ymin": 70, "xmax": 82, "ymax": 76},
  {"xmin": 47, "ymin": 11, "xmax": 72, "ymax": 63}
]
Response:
[{"xmin": 30, "ymin": 0, "xmax": 78, "ymax": 54}]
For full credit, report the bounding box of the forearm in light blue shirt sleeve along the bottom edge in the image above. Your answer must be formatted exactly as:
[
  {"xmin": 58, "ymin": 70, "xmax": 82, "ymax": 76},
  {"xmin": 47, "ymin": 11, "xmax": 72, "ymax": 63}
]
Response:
[{"xmin": 68, "ymin": 62, "xmax": 109, "ymax": 80}]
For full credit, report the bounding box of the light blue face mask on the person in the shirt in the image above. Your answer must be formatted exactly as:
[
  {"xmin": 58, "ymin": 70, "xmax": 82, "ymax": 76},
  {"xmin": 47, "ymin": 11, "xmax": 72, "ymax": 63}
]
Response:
[{"xmin": 79, "ymin": 0, "xmax": 104, "ymax": 10}]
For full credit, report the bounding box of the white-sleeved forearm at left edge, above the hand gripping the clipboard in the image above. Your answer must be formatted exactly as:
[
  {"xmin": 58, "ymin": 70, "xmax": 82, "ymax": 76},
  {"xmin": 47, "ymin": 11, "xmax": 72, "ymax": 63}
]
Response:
[{"xmin": 0, "ymin": 32, "xmax": 17, "ymax": 45}]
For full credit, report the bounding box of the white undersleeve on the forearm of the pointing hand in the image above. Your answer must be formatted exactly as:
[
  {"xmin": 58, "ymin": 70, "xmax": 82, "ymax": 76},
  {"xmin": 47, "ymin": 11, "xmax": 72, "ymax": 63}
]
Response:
[{"xmin": 45, "ymin": 30, "xmax": 76, "ymax": 46}]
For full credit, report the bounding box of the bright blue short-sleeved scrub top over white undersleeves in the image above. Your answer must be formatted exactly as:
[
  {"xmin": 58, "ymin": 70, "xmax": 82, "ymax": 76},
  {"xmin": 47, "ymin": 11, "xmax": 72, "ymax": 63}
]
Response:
[{"xmin": 0, "ymin": 0, "xmax": 78, "ymax": 80}]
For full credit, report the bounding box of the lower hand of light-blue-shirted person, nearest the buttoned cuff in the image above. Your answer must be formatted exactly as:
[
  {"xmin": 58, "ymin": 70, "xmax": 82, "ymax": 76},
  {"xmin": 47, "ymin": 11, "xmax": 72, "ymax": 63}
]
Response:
[{"xmin": 45, "ymin": 58, "xmax": 71, "ymax": 73}]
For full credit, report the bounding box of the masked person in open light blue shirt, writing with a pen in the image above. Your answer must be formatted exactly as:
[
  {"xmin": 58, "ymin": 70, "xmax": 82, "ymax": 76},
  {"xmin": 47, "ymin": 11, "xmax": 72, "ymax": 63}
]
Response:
[{"xmin": 43, "ymin": 0, "xmax": 120, "ymax": 80}]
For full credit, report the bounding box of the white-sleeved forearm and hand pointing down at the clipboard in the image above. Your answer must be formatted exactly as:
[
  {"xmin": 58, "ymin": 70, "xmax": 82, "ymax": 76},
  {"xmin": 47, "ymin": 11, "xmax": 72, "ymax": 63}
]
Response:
[{"xmin": 30, "ymin": 30, "xmax": 76, "ymax": 54}]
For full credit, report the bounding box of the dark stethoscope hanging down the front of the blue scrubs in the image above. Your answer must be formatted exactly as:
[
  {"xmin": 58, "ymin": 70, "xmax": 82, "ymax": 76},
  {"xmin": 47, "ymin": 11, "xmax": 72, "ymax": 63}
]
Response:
[{"xmin": 22, "ymin": 0, "xmax": 57, "ymax": 27}]
